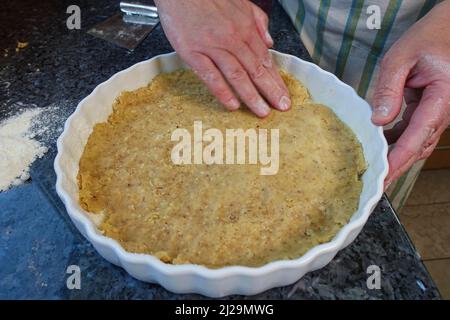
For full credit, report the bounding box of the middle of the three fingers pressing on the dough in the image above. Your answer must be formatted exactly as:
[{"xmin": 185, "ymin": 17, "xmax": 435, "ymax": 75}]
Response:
[{"xmin": 210, "ymin": 49, "xmax": 270, "ymax": 117}]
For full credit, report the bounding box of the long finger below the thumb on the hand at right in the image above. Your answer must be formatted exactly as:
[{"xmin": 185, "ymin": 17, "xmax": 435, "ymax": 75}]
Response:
[{"xmin": 386, "ymin": 86, "xmax": 450, "ymax": 184}]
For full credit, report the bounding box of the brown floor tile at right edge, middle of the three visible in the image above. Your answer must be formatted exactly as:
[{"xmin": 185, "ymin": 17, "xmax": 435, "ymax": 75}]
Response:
[{"xmin": 400, "ymin": 202, "xmax": 450, "ymax": 260}]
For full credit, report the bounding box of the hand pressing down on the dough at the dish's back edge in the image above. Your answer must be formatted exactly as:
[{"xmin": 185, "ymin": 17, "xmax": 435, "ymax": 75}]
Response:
[{"xmin": 155, "ymin": 0, "xmax": 291, "ymax": 117}]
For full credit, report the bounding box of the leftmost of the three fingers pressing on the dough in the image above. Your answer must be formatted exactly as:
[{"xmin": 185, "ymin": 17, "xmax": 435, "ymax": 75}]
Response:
[{"xmin": 183, "ymin": 53, "xmax": 240, "ymax": 111}]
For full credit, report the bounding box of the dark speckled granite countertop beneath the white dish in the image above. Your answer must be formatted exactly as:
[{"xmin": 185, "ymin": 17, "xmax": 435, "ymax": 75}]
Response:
[{"xmin": 0, "ymin": 0, "xmax": 440, "ymax": 299}]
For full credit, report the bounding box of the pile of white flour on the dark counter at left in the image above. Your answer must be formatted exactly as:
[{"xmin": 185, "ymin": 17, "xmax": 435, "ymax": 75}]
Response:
[{"xmin": 0, "ymin": 109, "xmax": 47, "ymax": 192}]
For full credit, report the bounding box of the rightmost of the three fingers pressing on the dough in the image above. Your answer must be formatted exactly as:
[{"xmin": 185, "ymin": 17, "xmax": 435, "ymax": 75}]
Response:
[{"xmin": 227, "ymin": 43, "xmax": 291, "ymax": 111}]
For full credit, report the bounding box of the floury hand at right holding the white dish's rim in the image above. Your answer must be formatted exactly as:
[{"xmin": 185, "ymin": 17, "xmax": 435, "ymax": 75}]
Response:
[{"xmin": 372, "ymin": 1, "xmax": 450, "ymax": 187}]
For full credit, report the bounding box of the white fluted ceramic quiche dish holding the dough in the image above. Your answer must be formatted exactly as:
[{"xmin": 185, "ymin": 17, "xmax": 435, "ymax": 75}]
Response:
[{"xmin": 55, "ymin": 51, "xmax": 388, "ymax": 297}]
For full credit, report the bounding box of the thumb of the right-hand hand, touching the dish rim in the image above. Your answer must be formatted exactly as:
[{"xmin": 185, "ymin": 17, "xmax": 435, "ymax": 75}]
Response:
[{"xmin": 372, "ymin": 53, "xmax": 410, "ymax": 126}]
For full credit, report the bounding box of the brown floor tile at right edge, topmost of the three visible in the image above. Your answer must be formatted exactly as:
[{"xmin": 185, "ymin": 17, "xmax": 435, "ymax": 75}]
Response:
[{"xmin": 406, "ymin": 169, "xmax": 450, "ymax": 206}]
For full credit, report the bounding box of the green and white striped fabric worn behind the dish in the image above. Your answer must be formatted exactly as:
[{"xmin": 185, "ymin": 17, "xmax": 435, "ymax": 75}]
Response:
[{"xmin": 279, "ymin": 0, "xmax": 440, "ymax": 210}]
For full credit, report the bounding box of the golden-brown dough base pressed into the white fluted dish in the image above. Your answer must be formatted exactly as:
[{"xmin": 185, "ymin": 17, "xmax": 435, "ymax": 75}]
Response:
[{"xmin": 78, "ymin": 71, "xmax": 365, "ymax": 268}]
